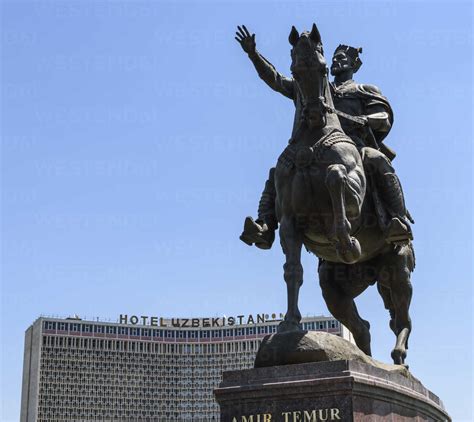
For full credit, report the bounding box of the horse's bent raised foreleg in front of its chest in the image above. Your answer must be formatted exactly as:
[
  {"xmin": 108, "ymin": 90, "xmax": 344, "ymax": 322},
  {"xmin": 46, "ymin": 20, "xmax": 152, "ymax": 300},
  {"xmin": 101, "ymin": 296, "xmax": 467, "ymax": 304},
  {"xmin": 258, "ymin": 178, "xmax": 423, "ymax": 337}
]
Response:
[{"xmin": 326, "ymin": 164, "xmax": 361, "ymax": 264}]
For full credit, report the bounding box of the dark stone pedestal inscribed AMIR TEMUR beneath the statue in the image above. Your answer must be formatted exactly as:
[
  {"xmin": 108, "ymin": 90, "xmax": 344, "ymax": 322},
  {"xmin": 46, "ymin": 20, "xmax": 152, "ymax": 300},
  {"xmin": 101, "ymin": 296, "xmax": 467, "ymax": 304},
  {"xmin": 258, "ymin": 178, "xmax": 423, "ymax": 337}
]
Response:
[{"xmin": 214, "ymin": 360, "xmax": 451, "ymax": 422}]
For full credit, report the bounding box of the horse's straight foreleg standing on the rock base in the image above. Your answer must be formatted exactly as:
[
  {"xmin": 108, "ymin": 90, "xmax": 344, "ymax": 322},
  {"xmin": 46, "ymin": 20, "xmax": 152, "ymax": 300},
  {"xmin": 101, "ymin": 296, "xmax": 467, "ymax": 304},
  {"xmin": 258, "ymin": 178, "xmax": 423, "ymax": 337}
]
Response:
[{"xmin": 278, "ymin": 217, "xmax": 303, "ymax": 332}]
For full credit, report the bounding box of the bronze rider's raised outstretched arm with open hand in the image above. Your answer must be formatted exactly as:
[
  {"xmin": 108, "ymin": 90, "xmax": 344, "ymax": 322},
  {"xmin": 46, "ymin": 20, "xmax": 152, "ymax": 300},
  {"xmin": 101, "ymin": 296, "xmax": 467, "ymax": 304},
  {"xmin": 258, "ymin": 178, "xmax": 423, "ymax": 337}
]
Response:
[{"xmin": 235, "ymin": 25, "xmax": 295, "ymax": 100}]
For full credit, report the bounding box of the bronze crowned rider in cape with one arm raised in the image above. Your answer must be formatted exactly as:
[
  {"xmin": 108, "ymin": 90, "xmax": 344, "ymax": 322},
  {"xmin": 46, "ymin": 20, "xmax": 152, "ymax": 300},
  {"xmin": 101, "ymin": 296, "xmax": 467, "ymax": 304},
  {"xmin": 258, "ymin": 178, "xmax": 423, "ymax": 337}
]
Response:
[{"xmin": 236, "ymin": 26, "xmax": 413, "ymax": 249}]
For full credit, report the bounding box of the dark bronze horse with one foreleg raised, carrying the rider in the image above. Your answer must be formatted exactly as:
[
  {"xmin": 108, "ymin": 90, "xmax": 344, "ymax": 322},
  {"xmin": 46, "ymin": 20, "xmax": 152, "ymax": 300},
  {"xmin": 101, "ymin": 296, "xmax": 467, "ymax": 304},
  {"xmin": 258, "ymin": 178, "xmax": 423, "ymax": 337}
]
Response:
[{"xmin": 275, "ymin": 25, "xmax": 415, "ymax": 364}]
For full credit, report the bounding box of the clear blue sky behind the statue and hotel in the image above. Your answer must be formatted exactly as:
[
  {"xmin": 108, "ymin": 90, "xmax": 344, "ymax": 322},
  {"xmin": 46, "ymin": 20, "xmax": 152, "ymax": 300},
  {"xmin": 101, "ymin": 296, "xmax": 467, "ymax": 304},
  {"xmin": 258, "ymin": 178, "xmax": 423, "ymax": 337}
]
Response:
[{"xmin": 1, "ymin": 0, "xmax": 473, "ymax": 421}]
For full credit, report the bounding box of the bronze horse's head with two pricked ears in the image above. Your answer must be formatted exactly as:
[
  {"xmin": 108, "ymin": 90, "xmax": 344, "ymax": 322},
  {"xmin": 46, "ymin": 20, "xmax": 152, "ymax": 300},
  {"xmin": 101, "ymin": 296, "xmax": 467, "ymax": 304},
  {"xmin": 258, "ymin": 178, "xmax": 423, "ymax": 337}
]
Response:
[{"xmin": 289, "ymin": 24, "xmax": 327, "ymax": 128}]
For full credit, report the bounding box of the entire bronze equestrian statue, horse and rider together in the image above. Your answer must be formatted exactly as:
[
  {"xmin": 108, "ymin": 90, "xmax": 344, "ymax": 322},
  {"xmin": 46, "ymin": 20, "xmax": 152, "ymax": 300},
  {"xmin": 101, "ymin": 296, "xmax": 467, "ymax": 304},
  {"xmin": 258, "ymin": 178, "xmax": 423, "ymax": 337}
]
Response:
[{"xmin": 236, "ymin": 25, "xmax": 415, "ymax": 364}]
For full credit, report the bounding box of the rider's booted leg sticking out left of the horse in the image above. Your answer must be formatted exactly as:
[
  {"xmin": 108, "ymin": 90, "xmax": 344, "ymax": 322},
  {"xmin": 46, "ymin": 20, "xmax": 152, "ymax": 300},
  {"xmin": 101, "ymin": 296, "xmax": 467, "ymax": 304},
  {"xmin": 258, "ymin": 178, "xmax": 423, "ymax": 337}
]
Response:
[{"xmin": 240, "ymin": 169, "xmax": 278, "ymax": 249}]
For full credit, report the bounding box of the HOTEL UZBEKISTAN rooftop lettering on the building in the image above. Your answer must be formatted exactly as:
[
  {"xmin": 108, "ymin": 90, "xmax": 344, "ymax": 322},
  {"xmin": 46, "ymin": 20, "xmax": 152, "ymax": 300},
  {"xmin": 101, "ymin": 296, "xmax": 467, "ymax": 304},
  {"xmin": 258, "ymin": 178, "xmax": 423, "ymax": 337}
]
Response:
[{"xmin": 119, "ymin": 313, "xmax": 284, "ymax": 328}]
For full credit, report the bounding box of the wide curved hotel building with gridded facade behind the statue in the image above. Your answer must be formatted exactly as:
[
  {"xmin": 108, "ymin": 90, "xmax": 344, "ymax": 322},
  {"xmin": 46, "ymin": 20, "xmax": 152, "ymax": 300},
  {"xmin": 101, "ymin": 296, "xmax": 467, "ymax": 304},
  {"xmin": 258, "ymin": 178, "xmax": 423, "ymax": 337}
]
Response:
[{"xmin": 20, "ymin": 314, "xmax": 350, "ymax": 422}]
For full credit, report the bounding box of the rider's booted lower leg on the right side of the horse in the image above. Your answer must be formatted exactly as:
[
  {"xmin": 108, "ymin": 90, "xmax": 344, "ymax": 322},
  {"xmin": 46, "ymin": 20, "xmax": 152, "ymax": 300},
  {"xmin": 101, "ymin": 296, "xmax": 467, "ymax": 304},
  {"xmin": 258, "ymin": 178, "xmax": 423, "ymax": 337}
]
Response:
[{"xmin": 382, "ymin": 173, "xmax": 414, "ymax": 244}]
